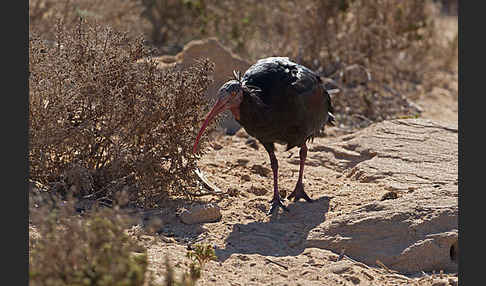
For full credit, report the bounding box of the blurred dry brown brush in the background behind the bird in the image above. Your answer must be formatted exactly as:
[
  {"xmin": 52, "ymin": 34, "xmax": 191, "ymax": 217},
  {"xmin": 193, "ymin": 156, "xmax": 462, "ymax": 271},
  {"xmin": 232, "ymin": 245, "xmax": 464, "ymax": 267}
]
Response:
[{"xmin": 137, "ymin": 0, "xmax": 457, "ymax": 127}]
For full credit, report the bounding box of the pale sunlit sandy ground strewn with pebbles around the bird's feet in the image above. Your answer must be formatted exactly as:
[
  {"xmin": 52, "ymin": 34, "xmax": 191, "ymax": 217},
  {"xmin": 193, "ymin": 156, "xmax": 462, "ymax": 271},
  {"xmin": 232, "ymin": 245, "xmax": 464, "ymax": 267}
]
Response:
[{"xmin": 139, "ymin": 15, "xmax": 459, "ymax": 285}]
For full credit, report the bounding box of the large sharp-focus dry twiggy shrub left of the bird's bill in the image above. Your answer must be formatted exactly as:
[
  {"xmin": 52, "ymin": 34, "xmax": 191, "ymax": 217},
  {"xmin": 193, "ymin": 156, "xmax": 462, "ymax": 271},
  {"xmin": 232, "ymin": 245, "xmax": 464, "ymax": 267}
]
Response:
[{"xmin": 29, "ymin": 21, "xmax": 213, "ymax": 207}]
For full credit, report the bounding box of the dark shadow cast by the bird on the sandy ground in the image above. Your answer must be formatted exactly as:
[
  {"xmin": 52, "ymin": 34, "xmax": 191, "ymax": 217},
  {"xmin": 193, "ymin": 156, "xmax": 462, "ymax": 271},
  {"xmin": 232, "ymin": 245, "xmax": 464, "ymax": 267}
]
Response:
[{"xmin": 215, "ymin": 196, "xmax": 331, "ymax": 261}]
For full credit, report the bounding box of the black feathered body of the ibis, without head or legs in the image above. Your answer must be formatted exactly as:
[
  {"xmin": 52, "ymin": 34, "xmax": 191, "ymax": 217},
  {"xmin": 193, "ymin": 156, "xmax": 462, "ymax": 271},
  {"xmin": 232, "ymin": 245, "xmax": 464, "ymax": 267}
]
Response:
[{"xmin": 237, "ymin": 57, "xmax": 334, "ymax": 150}]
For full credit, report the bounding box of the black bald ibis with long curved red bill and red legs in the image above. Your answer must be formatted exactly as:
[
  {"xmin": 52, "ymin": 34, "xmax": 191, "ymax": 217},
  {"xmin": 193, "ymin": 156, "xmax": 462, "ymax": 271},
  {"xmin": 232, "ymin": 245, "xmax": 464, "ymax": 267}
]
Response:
[{"xmin": 193, "ymin": 57, "xmax": 334, "ymax": 214}]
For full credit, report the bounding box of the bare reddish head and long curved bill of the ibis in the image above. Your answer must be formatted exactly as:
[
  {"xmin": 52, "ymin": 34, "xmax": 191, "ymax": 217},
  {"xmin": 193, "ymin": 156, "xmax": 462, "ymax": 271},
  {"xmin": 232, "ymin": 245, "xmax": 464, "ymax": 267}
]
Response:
[{"xmin": 192, "ymin": 80, "xmax": 243, "ymax": 153}]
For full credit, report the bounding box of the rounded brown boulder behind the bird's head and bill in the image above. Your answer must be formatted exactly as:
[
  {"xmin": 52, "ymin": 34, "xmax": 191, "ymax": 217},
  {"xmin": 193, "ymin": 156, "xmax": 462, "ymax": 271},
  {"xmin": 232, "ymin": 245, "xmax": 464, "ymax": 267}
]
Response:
[{"xmin": 140, "ymin": 38, "xmax": 251, "ymax": 135}]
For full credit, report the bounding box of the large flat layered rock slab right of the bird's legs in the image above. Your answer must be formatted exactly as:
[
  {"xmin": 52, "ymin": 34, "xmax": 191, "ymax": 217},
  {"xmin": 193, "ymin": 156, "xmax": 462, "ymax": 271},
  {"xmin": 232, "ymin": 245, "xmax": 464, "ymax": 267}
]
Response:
[{"xmin": 306, "ymin": 119, "xmax": 458, "ymax": 273}]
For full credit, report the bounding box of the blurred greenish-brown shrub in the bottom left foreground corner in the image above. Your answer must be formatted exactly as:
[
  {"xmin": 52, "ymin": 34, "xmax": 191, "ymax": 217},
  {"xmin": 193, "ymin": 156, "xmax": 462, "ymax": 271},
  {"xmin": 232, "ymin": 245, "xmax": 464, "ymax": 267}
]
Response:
[{"xmin": 29, "ymin": 201, "xmax": 154, "ymax": 286}]
